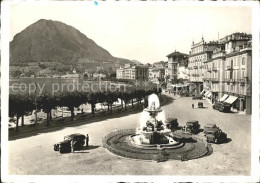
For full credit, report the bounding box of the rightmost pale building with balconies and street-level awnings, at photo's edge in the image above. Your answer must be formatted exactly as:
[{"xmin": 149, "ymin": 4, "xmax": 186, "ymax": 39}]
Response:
[{"xmin": 221, "ymin": 33, "xmax": 252, "ymax": 114}]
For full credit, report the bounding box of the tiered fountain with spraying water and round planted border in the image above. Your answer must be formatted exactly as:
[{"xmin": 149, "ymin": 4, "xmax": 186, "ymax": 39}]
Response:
[{"xmin": 102, "ymin": 94, "xmax": 212, "ymax": 162}]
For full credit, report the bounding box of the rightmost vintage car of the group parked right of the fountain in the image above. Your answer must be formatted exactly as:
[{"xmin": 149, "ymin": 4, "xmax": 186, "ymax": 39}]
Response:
[{"xmin": 203, "ymin": 124, "xmax": 227, "ymax": 143}]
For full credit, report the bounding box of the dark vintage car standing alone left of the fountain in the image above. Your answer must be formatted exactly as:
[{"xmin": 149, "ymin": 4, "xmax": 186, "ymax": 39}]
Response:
[{"xmin": 53, "ymin": 133, "xmax": 86, "ymax": 153}]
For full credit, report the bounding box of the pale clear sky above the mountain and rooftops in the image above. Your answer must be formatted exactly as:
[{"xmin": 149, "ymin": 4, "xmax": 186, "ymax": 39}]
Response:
[{"xmin": 10, "ymin": 1, "xmax": 252, "ymax": 63}]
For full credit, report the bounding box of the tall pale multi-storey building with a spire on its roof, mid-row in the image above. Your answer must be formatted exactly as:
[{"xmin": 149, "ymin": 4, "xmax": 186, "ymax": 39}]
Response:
[{"xmin": 188, "ymin": 37, "xmax": 219, "ymax": 93}]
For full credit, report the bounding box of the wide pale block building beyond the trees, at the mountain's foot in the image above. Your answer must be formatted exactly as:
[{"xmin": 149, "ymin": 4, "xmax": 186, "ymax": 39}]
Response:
[{"xmin": 116, "ymin": 64, "xmax": 149, "ymax": 80}]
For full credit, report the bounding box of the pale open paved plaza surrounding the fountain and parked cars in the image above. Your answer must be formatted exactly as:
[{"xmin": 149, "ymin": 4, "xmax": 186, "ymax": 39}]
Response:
[{"xmin": 9, "ymin": 93, "xmax": 251, "ymax": 175}]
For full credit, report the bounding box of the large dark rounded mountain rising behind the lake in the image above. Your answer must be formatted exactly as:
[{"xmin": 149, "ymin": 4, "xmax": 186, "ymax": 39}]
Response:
[{"xmin": 10, "ymin": 19, "xmax": 140, "ymax": 69}]
